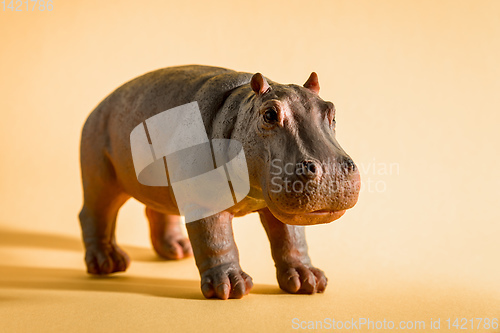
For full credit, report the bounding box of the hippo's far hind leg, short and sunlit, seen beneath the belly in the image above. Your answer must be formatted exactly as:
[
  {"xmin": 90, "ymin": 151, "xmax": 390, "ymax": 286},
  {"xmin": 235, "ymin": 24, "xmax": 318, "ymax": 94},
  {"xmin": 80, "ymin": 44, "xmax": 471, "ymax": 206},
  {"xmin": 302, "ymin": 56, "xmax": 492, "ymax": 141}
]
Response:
[{"xmin": 146, "ymin": 207, "xmax": 193, "ymax": 259}]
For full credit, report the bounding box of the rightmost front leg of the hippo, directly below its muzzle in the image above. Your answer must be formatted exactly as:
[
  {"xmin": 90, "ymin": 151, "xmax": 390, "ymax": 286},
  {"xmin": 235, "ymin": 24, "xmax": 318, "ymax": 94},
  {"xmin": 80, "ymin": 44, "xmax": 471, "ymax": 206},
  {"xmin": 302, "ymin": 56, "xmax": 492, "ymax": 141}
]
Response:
[{"xmin": 259, "ymin": 208, "xmax": 328, "ymax": 294}]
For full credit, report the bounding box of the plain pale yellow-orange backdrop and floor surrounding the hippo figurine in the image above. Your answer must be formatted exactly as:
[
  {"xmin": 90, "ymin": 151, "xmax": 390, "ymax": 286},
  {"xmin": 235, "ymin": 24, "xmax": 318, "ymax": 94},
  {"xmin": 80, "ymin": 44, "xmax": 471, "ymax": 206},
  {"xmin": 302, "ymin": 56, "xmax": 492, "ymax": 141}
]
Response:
[{"xmin": 0, "ymin": 0, "xmax": 500, "ymax": 332}]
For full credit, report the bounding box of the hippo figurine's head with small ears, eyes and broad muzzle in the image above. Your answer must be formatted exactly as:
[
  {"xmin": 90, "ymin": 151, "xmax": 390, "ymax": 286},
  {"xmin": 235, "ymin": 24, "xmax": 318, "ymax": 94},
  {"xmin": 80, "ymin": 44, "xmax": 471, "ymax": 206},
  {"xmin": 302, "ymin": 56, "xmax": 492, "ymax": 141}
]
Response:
[{"xmin": 237, "ymin": 72, "xmax": 360, "ymax": 225}]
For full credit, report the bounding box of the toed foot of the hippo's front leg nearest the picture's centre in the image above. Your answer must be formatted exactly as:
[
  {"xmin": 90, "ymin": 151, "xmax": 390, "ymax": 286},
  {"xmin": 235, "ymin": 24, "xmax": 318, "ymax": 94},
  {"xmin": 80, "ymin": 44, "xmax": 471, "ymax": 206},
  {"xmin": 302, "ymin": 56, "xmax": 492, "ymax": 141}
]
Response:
[{"xmin": 201, "ymin": 263, "xmax": 253, "ymax": 300}]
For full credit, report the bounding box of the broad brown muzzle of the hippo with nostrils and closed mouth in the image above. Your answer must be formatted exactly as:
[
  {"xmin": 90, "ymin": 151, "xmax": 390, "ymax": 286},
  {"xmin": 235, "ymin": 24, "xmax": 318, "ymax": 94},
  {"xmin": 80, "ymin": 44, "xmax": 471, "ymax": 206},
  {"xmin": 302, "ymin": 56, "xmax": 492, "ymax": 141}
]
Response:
[{"xmin": 263, "ymin": 156, "xmax": 360, "ymax": 225}]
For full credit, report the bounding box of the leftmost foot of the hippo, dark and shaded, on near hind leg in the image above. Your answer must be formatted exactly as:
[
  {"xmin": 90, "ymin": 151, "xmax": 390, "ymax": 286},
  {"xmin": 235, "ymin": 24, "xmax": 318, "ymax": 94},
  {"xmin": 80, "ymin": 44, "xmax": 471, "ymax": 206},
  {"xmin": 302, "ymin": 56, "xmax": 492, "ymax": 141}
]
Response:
[{"xmin": 85, "ymin": 244, "xmax": 130, "ymax": 275}]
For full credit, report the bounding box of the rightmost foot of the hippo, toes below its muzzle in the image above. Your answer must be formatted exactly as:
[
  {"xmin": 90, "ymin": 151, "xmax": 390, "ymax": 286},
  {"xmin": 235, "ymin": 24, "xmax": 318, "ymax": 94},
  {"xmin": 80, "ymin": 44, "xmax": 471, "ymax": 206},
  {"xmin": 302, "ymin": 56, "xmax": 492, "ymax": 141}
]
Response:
[{"xmin": 276, "ymin": 262, "xmax": 328, "ymax": 294}]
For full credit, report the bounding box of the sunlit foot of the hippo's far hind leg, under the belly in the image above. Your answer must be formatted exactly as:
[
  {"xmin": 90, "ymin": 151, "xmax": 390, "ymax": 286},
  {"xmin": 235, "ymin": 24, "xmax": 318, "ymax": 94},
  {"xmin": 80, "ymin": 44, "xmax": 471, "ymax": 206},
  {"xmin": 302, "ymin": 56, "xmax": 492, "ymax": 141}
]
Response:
[{"xmin": 152, "ymin": 230, "xmax": 193, "ymax": 260}]
